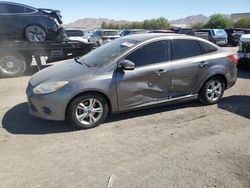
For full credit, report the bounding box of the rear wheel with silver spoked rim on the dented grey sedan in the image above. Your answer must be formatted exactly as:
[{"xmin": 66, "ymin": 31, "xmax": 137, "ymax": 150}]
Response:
[{"xmin": 198, "ymin": 77, "xmax": 225, "ymax": 105}]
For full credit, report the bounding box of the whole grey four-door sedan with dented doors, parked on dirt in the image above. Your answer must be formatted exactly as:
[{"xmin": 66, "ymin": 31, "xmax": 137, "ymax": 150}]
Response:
[{"xmin": 27, "ymin": 34, "xmax": 237, "ymax": 129}]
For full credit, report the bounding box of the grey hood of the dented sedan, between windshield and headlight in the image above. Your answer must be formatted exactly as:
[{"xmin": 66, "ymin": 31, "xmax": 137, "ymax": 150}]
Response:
[{"xmin": 30, "ymin": 60, "xmax": 97, "ymax": 87}]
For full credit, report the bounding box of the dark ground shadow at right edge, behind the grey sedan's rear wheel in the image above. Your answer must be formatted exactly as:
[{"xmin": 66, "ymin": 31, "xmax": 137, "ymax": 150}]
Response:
[{"xmin": 218, "ymin": 95, "xmax": 250, "ymax": 119}]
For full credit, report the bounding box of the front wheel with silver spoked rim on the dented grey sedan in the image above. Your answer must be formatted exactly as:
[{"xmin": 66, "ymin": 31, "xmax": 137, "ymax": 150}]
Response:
[{"xmin": 68, "ymin": 94, "xmax": 108, "ymax": 129}]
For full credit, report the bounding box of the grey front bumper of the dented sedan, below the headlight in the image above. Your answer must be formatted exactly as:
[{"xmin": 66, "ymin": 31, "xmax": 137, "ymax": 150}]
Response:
[{"xmin": 26, "ymin": 84, "xmax": 67, "ymax": 121}]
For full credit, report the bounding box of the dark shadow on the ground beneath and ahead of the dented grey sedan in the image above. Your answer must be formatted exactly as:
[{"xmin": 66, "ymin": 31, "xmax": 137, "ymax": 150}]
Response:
[{"xmin": 2, "ymin": 101, "xmax": 201, "ymax": 135}]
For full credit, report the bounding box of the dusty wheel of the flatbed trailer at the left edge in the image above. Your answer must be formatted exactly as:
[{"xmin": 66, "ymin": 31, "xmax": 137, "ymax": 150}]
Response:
[{"xmin": 0, "ymin": 54, "xmax": 26, "ymax": 78}]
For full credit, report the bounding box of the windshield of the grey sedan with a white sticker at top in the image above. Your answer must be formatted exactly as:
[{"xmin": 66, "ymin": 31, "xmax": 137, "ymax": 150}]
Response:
[{"xmin": 79, "ymin": 38, "xmax": 140, "ymax": 66}]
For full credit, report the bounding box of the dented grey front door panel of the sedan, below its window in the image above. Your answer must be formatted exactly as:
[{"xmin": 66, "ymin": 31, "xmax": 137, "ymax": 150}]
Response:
[{"xmin": 116, "ymin": 62, "xmax": 171, "ymax": 110}]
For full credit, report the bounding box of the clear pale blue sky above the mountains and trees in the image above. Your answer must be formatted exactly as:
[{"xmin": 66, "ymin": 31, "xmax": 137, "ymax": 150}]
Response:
[{"xmin": 6, "ymin": 0, "xmax": 250, "ymax": 24}]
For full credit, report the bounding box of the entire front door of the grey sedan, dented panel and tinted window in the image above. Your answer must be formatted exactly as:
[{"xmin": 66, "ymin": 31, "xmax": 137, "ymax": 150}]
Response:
[{"xmin": 116, "ymin": 40, "xmax": 171, "ymax": 110}]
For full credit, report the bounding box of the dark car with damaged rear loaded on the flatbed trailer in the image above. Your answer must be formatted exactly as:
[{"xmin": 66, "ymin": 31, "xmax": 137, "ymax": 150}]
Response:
[{"xmin": 0, "ymin": 1, "xmax": 63, "ymax": 42}]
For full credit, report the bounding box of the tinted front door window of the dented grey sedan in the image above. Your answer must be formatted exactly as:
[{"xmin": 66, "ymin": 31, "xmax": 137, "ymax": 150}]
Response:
[{"xmin": 126, "ymin": 41, "xmax": 170, "ymax": 66}]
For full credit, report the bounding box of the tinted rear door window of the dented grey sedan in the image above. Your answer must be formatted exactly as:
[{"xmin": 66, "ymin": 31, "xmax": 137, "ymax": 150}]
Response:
[{"xmin": 173, "ymin": 39, "xmax": 202, "ymax": 59}]
